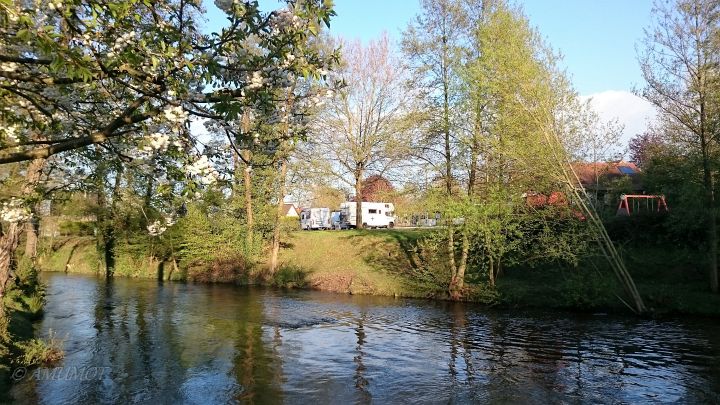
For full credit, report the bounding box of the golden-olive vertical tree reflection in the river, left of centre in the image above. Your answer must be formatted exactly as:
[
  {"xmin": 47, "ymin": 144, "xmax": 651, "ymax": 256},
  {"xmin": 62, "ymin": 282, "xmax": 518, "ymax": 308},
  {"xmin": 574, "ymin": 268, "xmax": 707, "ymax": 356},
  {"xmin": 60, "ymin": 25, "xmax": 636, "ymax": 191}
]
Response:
[{"xmin": 233, "ymin": 289, "xmax": 283, "ymax": 404}]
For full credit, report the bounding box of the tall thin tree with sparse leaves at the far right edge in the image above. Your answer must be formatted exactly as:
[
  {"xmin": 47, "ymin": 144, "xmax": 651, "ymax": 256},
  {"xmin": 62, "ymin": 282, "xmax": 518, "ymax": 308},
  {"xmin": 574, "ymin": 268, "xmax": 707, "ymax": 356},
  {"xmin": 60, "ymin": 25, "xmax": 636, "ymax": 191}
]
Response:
[{"xmin": 639, "ymin": 0, "xmax": 720, "ymax": 292}]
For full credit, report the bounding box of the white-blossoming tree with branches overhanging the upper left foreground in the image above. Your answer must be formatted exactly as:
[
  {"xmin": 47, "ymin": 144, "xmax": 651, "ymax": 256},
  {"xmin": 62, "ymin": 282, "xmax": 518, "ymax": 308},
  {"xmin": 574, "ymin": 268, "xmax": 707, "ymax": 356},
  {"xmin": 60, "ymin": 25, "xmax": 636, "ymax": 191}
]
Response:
[{"xmin": 0, "ymin": 0, "xmax": 333, "ymax": 315}]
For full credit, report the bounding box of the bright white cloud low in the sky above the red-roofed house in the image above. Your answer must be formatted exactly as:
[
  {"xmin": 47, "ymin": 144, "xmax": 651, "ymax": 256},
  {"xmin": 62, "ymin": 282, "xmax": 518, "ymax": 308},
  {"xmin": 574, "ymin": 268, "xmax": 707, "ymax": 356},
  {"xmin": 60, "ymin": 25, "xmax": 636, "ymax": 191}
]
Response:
[{"xmin": 580, "ymin": 90, "xmax": 657, "ymax": 145}]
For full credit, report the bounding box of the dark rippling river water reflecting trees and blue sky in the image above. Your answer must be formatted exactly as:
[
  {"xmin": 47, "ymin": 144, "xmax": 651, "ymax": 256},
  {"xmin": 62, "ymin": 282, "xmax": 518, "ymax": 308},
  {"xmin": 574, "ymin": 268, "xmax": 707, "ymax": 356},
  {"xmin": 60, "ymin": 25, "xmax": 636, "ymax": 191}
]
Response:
[{"xmin": 8, "ymin": 274, "xmax": 720, "ymax": 405}]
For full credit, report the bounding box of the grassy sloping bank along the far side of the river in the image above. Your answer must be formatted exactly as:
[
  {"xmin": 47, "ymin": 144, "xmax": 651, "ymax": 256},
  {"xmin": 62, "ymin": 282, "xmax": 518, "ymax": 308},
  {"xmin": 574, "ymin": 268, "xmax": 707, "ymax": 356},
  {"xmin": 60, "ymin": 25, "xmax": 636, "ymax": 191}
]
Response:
[{"xmin": 40, "ymin": 229, "xmax": 720, "ymax": 316}]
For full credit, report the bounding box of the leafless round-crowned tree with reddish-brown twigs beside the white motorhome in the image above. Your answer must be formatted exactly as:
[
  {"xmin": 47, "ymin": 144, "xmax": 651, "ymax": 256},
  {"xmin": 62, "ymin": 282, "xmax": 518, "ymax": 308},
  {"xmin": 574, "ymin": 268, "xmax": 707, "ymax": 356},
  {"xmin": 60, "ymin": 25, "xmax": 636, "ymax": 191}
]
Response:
[{"xmin": 305, "ymin": 35, "xmax": 413, "ymax": 228}]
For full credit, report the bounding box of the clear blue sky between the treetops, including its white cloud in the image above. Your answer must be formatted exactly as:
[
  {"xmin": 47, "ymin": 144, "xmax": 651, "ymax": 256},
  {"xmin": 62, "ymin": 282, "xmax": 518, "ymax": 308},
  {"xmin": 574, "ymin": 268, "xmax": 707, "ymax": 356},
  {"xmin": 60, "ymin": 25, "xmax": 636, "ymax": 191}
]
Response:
[{"xmin": 205, "ymin": 0, "xmax": 654, "ymax": 142}]
